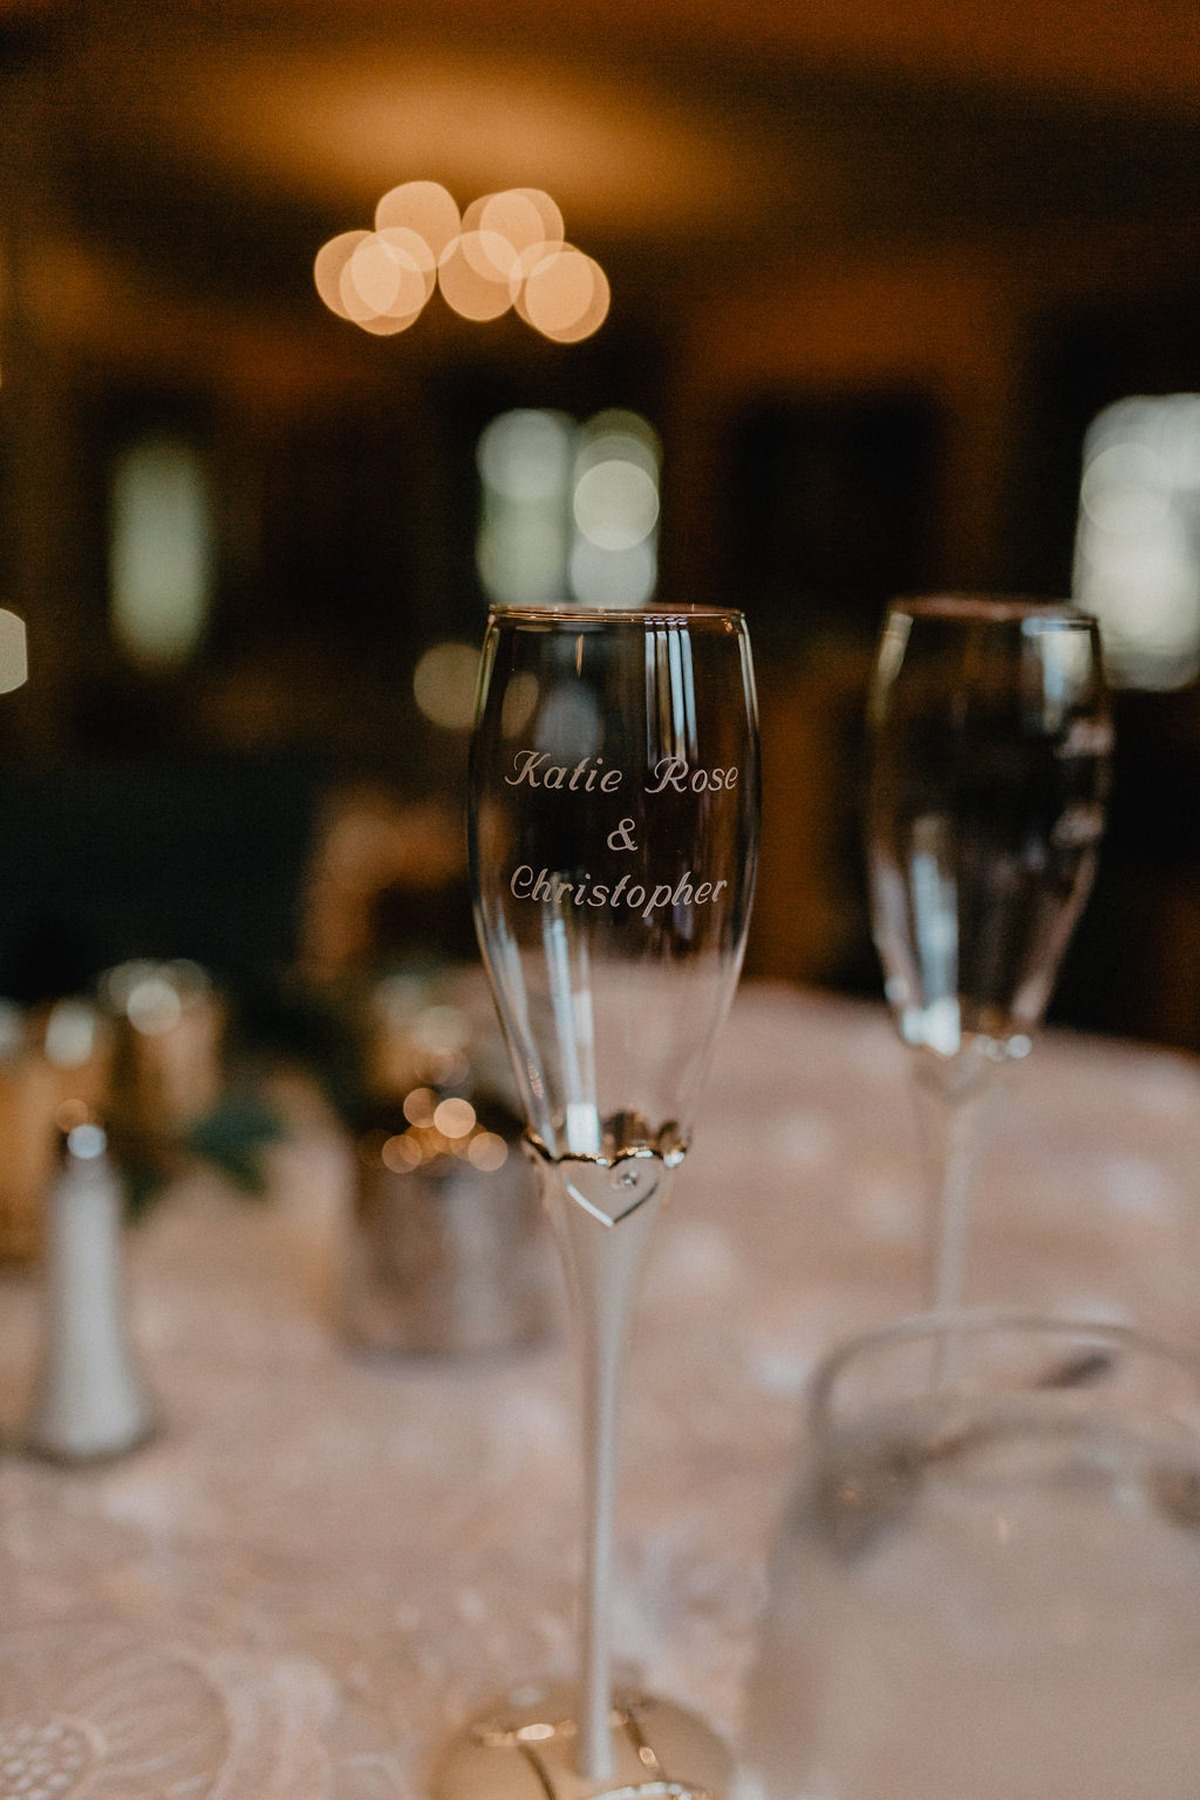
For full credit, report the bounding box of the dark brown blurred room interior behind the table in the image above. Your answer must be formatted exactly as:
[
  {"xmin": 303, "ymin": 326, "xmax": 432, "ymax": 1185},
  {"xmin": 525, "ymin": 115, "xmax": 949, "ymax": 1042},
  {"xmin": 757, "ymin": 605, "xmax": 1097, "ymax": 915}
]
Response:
[{"xmin": 0, "ymin": 0, "xmax": 1200, "ymax": 1048}]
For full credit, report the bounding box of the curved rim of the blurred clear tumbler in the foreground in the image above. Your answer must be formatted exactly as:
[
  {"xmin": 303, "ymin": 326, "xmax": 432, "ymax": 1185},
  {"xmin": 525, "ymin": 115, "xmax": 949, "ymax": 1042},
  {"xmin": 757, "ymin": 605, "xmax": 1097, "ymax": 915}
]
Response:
[{"xmin": 808, "ymin": 1307, "xmax": 1200, "ymax": 1440}]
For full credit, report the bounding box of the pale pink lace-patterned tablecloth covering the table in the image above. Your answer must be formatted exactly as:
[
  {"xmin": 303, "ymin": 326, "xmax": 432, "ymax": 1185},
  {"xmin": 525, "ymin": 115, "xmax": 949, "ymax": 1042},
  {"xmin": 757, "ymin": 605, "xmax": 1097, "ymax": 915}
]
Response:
[{"xmin": 0, "ymin": 988, "xmax": 1200, "ymax": 1800}]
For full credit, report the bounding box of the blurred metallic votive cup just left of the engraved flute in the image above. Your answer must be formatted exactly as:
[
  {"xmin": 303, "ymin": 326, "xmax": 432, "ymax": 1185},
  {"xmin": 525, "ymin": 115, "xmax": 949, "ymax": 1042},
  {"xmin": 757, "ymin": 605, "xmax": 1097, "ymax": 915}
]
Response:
[{"xmin": 345, "ymin": 1102, "xmax": 549, "ymax": 1355}]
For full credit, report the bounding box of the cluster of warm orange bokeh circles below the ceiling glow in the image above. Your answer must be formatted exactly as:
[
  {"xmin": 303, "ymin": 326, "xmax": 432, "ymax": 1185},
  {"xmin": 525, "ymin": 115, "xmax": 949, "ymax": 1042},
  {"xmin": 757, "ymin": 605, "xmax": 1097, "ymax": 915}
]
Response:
[{"xmin": 313, "ymin": 182, "xmax": 610, "ymax": 344}]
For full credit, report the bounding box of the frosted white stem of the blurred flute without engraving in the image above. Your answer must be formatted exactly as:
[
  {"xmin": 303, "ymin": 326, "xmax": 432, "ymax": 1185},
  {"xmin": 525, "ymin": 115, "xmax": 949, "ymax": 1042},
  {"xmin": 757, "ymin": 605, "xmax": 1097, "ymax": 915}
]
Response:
[{"xmin": 916, "ymin": 1071, "xmax": 995, "ymax": 1312}]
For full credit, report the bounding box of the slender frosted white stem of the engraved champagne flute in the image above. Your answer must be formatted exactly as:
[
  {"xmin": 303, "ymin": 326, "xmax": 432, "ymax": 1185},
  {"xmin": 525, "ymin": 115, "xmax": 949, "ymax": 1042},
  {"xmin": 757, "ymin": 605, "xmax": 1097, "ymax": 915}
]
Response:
[{"xmin": 540, "ymin": 1161, "xmax": 669, "ymax": 1782}]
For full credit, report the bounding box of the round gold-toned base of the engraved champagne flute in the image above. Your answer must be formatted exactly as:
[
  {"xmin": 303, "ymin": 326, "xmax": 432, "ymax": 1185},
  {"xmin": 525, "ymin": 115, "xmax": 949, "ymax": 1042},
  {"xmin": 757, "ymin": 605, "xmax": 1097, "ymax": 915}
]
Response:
[{"xmin": 432, "ymin": 1685, "xmax": 732, "ymax": 1800}]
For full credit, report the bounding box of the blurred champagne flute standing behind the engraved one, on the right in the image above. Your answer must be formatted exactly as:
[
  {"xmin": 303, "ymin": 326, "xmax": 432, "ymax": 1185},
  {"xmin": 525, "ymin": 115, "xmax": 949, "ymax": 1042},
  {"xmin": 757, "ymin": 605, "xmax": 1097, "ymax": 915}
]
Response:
[{"xmin": 867, "ymin": 596, "xmax": 1112, "ymax": 1310}]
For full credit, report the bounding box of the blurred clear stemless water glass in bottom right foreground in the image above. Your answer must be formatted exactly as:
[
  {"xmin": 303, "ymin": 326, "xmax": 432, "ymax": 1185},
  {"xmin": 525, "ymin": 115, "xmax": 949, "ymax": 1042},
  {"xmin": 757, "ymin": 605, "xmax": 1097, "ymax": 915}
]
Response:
[{"xmin": 739, "ymin": 1314, "xmax": 1200, "ymax": 1800}]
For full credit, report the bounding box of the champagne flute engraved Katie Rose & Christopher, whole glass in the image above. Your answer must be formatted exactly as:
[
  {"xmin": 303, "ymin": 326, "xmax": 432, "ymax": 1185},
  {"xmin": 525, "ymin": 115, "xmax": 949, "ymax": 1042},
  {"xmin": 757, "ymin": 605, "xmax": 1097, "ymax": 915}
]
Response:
[{"xmin": 437, "ymin": 607, "xmax": 759, "ymax": 1800}]
